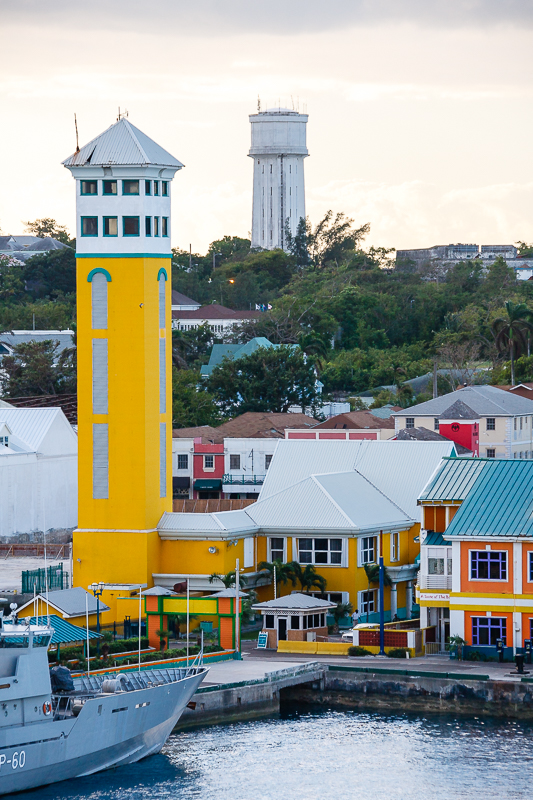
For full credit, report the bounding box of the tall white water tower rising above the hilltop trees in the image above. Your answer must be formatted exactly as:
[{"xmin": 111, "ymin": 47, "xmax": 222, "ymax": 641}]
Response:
[{"xmin": 248, "ymin": 108, "xmax": 309, "ymax": 250}]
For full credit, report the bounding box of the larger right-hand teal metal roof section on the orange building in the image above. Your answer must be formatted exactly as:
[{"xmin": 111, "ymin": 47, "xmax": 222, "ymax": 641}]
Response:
[{"xmin": 445, "ymin": 459, "xmax": 533, "ymax": 539}]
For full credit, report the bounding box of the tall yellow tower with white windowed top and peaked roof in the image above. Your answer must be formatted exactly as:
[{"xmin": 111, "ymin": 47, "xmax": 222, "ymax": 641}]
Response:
[{"xmin": 63, "ymin": 118, "xmax": 183, "ymax": 613}]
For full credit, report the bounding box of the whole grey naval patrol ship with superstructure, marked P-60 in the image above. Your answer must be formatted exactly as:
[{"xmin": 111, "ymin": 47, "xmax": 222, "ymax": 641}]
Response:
[{"xmin": 0, "ymin": 615, "xmax": 208, "ymax": 795}]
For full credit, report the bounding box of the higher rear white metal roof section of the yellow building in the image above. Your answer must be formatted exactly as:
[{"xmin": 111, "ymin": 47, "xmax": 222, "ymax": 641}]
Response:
[{"xmin": 258, "ymin": 439, "xmax": 455, "ymax": 519}]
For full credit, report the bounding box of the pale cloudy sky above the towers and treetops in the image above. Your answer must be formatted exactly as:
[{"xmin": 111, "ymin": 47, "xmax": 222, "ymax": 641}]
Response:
[{"xmin": 0, "ymin": 0, "xmax": 533, "ymax": 253}]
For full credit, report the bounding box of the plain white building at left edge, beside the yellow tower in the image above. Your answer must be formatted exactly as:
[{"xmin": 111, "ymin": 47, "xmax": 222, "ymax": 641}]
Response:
[{"xmin": 0, "ymin": 407, "xmax": 78, "ymax": 537}]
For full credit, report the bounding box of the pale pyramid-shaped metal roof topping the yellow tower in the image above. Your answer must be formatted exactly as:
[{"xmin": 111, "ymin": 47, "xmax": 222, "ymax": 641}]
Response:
[{"xmin": 63, "ymin": 117, "xmax": 183, "ymax": 169}]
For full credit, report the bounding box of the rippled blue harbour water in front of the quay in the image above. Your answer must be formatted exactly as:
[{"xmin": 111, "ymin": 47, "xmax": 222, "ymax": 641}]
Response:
[{"xmin": 11, "ymin": 710, "xmax": 533, "ymax": 800}]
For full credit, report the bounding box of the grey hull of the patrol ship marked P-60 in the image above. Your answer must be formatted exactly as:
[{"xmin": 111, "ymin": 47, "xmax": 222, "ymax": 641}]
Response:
[{"xmin": 0, "ymin": 671, "xmax": 206, "ymax": 795}]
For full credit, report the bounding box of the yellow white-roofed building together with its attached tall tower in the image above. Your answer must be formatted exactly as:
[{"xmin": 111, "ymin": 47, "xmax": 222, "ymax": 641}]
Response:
[{"xmin": 64, "ymin": 118, "xmax": 455, "ymax": 623}]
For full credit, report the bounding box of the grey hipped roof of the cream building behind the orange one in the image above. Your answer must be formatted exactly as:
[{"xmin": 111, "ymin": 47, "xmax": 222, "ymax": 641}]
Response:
[{"xmin": 393, "ymin": 386, "xmax": 533, "ymax": 418}]
